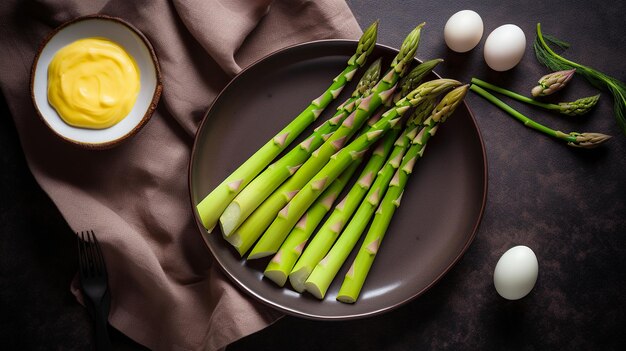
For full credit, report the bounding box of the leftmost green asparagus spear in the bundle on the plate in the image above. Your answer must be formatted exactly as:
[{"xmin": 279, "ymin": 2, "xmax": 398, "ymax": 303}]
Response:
[{"xmin": 197, "ymin": 22, "xmax": 378, "ymax": 233}]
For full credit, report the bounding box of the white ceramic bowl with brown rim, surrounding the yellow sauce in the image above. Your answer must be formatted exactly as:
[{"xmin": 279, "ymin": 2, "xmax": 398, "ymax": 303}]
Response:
[{"xmin": 30, "ymin": 15, "xmax": 162, "ymax": 149}]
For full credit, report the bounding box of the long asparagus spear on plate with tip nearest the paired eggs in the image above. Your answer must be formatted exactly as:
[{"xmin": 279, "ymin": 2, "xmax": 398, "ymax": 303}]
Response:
[{"xmin": 227, "ymin": 24, "xmax": 423, "ymax": 258}]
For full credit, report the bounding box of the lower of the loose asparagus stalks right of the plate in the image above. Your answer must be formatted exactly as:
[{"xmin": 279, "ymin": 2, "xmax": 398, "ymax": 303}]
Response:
[{"xmin": 470, "ymin": 84, "xmax": 611, "ymax": 149}]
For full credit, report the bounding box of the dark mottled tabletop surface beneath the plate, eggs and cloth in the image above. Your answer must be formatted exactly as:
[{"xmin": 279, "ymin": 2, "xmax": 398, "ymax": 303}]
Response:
[{"xmin": 0, "ymin": 0, "xmax": 626, "ymax": 350}]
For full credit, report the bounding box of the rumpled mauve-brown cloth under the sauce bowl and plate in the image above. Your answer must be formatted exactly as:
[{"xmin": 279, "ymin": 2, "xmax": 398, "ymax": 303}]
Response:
[{"xmin": 0, "ymin": 0, "xmax": 360, "ymax": 350}]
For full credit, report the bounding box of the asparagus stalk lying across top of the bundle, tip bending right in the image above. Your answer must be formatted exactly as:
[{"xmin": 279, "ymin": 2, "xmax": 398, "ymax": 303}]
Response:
[{"xmin": 250, "ymin": 79, "xmax": 460, "ymax": 258}]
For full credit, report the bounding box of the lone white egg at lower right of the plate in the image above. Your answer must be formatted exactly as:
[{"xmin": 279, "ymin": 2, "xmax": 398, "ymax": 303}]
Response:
[{"xmin": 493, "ymin": 245, "xmax": 539, "ymax": 300}]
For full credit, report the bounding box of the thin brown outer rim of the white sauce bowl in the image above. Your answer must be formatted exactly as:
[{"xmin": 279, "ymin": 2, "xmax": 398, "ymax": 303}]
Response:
[{"xmin": 30, "ymin": 14, "xmax": 163, "ymax": 150}]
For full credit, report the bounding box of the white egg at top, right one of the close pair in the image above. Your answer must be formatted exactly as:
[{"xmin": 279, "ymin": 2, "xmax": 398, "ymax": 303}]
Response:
[{"xmin": 484, "ymin": 24, "xmax": 526, "ymax": 71}]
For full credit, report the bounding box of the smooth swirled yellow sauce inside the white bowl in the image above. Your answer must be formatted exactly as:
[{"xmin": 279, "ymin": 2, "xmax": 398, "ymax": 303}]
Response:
[{"xmin": 48, "ymin": 38, "xmax": 141, "ymax": 129}]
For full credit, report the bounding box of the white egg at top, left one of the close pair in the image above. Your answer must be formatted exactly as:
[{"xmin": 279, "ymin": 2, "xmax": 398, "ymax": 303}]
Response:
[{"xmin": 443, "ymin": 10, "xmax": 483, "ymax": 52}]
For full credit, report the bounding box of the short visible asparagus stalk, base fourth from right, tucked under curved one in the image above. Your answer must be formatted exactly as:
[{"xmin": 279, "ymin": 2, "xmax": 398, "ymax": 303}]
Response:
[{"xmin": 263, "ymin": 162, "xmax": 360, "ymax": 286}]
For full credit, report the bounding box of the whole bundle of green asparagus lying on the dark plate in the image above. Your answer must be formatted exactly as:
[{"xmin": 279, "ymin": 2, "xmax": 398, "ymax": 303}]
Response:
[{"xmin": 197, "ymin": 23, "xmax": 467, "ymax": 302}]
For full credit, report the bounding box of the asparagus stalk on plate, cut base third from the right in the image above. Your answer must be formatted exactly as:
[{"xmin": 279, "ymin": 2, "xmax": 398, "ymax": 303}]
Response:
[{"xmin": 289, "ymin": 100, "xmax": 434, "ymax": 292}]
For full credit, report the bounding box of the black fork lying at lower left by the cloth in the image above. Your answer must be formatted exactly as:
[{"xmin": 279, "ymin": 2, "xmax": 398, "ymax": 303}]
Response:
[{"xmin": 76, "ymin": 230, "xmax": 111, "ymax": 350}]
